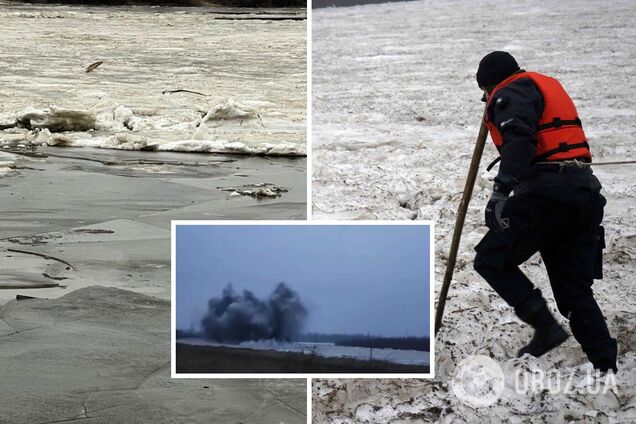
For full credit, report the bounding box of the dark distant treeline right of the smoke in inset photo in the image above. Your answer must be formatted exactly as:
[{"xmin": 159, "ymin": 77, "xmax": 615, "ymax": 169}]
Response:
[{"xmin": 297, "ymin": 333, "xmax": 431, "ymax": 352}]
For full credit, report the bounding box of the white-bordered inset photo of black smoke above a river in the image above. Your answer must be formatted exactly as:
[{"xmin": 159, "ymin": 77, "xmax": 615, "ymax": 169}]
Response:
[{"xmin": 172, "ymin": 221, "xmax": 434, "ymax": 378}]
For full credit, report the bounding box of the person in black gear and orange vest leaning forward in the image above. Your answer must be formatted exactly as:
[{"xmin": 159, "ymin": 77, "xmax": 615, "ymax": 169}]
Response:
[{"xmin": 474, "ymin": 51, "xmax": 617, "ymax": 372}]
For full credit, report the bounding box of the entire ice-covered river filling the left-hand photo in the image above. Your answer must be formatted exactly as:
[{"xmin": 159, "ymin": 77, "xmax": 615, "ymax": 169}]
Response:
[{"xmin": 0, "ymin": 0, "xmax": 306, "ymax": 424}]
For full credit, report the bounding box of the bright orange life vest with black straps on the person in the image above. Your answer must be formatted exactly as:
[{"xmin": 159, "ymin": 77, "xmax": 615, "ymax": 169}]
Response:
[{"xmin": 485, "ymin": 72, "xmax": 592, "ymax": 163}]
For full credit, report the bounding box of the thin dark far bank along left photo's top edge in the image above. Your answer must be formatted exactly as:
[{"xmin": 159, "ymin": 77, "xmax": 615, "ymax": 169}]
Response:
[{"xmin": 7, "ymin": 0, "xmax": 307, "ymax": 7}]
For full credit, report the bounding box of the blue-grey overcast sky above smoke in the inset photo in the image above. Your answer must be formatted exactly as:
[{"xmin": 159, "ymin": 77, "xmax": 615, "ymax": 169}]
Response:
[{"xmin": 176, "ymin": 225, "xmax": 430, "ymax": 336}]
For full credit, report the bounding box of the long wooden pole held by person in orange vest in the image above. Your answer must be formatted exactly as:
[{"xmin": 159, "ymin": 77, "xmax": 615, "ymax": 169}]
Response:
[{"xmin": 435, "ymin": 109, "xmax": 488, "ymax": 334}]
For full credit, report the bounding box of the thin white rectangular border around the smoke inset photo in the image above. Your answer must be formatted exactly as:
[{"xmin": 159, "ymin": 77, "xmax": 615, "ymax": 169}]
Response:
[{"xmin": 170, "ymin": 220, "xmax": 435, "ymax": 380}]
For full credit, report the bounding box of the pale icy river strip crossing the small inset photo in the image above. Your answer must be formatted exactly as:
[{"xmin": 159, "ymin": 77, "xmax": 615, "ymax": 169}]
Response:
[{"xmin": 179, "ymin": 339, "xmax": 429, "ymax": 365}]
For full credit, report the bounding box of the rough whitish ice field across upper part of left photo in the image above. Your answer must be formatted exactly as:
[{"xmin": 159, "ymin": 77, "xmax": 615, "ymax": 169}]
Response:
[{"xmin": 0, "ymin": 0, "xmax": 307, "ymax": 156}]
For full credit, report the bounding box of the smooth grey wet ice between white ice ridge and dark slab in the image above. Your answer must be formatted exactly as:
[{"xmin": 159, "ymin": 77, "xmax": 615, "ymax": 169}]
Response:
[{"xmin": 0, "ymin": 147, "xmax": 306, "ymax": 304}]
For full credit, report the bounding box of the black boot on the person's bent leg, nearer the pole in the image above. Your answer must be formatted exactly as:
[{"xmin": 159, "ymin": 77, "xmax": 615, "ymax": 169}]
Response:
[{"xmin": 515, "ymin": 290, "xmax": 570, "ymax": 358}]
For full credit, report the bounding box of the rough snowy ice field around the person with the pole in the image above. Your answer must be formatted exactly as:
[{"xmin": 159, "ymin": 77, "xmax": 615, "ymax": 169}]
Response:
[{"xmin": 313, "ymin": 0, "xmax": 636, "ymax": 423}]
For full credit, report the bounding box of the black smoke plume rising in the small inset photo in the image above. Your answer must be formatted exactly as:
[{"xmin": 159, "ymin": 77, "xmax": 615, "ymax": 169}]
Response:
[{"xmin": 201, "ymin": 283, "xmax": 307, "ymax": 343}]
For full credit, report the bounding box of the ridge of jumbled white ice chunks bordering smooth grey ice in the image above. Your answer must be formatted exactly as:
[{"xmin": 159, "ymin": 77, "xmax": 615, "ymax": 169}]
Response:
[{"xmin": 0, "ymin": 98, "xmax": 307, "ymax": 157}]
